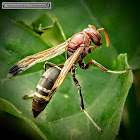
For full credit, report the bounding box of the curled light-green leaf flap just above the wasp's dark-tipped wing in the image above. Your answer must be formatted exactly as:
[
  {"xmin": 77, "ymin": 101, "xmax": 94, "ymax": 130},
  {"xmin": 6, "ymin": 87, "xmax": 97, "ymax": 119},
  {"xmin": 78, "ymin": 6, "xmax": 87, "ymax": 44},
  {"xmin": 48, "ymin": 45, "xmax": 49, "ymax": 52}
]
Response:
[{"xmin": 32, "ymin": 14, "xmax": 66, "ymax": 46}]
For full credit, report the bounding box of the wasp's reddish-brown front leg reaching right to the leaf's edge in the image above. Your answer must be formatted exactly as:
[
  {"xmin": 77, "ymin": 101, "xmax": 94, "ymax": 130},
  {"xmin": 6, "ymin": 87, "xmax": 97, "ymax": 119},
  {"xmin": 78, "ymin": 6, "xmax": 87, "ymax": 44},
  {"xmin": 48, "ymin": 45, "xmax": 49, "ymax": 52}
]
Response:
[{"xmin": 79, "ymin": 59, "xmax": 132, "ymax": 74}]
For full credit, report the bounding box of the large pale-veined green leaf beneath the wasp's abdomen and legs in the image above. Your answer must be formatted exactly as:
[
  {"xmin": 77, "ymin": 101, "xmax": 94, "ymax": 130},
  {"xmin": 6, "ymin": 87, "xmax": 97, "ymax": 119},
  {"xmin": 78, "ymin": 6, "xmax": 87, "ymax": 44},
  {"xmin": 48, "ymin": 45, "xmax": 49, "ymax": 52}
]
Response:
[{"xmin": 1, "ymin": 52, "xmax": 133, "ymax": 139}]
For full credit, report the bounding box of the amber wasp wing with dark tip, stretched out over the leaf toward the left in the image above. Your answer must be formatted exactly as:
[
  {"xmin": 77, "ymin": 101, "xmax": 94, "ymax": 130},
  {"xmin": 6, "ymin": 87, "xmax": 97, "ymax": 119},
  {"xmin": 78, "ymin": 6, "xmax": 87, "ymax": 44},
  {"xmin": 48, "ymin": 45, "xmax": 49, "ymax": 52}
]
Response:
[{"xmin": 7, "ymin": 41, "xmax": 68, "ymax": 78}]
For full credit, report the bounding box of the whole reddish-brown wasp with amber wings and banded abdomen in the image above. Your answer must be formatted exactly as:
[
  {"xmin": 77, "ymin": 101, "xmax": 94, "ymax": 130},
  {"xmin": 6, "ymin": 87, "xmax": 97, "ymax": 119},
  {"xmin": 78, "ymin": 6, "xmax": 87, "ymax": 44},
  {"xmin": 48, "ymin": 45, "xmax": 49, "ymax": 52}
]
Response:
[{"xmin": 8, "ymin": 25, "xmax": 132, "ymax": 132}]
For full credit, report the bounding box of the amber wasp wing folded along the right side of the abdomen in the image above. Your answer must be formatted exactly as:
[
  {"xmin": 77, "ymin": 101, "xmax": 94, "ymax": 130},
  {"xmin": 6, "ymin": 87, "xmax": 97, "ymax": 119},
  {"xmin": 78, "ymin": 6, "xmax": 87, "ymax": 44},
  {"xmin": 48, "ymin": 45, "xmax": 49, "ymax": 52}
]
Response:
[{"xmin": 49, "ymin": 47, "xmax": 84, "ymax": 97}]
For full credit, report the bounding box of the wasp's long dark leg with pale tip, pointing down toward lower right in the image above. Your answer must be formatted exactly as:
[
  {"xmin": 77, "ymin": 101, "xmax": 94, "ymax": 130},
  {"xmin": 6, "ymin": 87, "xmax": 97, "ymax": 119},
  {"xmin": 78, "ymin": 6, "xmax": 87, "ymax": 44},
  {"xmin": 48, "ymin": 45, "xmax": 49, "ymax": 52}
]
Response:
[{"xmin": 72, "ymin": 65, "xmax": 103, "ymax": 132}]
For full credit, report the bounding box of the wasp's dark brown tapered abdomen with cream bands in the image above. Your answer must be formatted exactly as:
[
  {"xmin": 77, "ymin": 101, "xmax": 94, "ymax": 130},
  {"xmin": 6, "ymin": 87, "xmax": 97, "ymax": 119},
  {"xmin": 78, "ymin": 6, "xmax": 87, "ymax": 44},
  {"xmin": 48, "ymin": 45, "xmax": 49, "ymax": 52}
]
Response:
[{"xmin": 32, "ymin": 66, "xmax": 61, "ymax": 118}]
